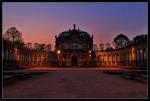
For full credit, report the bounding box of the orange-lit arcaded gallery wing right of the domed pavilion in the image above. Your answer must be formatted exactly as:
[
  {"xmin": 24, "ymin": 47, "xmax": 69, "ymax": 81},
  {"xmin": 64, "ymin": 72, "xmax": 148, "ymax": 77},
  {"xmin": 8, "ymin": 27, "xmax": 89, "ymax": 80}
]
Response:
[{"xmin": 96, "ymin": 39, "xmax": 148, "ymax": 67}]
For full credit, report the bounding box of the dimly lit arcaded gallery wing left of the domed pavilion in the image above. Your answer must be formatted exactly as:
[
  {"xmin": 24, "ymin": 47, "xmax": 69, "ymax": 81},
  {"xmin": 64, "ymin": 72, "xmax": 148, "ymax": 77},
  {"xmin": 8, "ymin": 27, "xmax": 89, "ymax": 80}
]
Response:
[{"xmin": 2, "ymin": 40, "xmax": 54, "ymax": 68}]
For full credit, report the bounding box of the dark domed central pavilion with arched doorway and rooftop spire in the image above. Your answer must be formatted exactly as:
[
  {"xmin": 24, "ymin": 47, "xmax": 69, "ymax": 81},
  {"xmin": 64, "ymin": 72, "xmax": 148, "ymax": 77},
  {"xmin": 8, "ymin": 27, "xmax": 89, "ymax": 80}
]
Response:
[{"xmin": 55, "ymin": 24, "xmax": 93, "ymax": 66}]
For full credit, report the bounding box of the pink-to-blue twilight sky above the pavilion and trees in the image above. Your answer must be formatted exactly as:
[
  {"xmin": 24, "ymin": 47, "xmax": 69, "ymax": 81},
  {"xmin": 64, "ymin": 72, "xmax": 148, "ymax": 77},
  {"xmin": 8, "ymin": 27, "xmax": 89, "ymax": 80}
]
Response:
[{"xmin": 2, "ymin": 2, "xmax": 148, "ymax": 47}]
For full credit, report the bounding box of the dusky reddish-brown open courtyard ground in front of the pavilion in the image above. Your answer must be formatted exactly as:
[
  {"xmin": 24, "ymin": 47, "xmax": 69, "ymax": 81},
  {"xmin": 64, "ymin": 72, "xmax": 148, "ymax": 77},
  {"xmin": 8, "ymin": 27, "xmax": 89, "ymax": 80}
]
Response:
[{"xmin": 3, "ymin": 69, "xmax": 147, "ymax": 98}]
